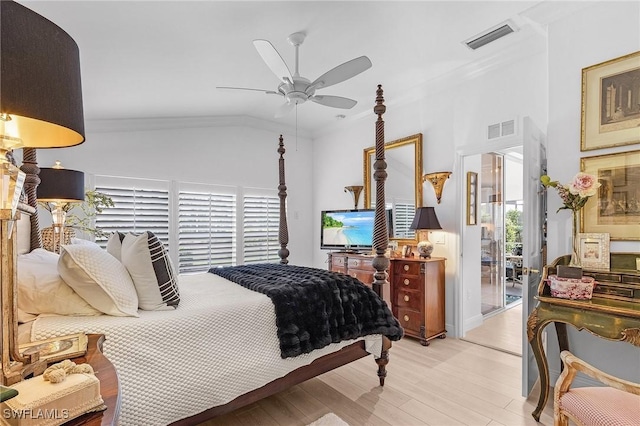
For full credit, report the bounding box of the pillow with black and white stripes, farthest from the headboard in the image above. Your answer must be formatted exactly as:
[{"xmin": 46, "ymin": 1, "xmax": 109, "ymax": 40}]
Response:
[{"xmin": 121, "ymin": 231, "xmax": 180, "ymax": 311}]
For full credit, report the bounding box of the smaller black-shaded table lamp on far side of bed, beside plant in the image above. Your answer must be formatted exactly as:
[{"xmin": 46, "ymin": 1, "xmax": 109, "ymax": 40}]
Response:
[{"xmin": 37, "ymin": 161, "xmax": 84, "ymax": 253}]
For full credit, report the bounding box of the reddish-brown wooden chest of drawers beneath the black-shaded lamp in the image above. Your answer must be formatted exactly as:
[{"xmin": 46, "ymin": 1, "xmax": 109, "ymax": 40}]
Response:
[{"xmin": 389, "ymin": 257, "xmax": 447, "ymax": 346}]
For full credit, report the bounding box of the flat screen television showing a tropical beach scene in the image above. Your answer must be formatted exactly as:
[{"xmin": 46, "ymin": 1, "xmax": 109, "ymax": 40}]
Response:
[{"xmin": 320, "ymin": 209, "xmax": 375, "ymax": 251}]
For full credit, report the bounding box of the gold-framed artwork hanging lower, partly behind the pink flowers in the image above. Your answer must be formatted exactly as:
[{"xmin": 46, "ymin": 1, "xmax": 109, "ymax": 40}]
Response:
[{"xmin": 580, "ymin": 151, "xmax": 640, "ymax": 241}]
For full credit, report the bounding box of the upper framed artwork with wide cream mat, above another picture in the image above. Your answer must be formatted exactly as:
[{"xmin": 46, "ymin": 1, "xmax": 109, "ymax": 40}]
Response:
[{"xmin": 580, "ymin": 51, "xmax": 640, "ymax": 151}]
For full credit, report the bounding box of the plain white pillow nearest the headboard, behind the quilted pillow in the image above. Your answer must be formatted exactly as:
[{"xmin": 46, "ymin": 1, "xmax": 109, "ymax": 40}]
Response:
[{"xmin": 17, "ymin": 248, "xmax": 101, "ymax": 315}]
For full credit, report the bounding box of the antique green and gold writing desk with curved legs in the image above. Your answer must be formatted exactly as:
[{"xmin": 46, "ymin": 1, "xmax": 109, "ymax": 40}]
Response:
[{"xmin": 527, "ymin": 253, "xmax": 640, "ymax": 420}]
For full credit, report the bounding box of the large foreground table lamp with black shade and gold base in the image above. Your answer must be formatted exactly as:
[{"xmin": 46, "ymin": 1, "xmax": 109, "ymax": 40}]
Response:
[{"xmin": 0, "ymin": 1, "xmax": 84, "ymax": 385}]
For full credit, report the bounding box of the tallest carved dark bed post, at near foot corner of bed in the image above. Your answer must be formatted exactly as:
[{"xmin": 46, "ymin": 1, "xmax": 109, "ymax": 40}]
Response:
[{"xmin": 372, "ymin": 84, "xmax": 391, "ymax": 386}]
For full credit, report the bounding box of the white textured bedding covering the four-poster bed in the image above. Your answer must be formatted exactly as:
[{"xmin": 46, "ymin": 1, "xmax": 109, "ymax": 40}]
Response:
[{"xmin": 31, "ymin": 273, "xmax": 381, "ymax": 426}]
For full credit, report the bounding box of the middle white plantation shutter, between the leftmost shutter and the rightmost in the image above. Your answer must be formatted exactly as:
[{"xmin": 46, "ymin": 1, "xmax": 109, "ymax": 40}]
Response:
[{"xmin": 178, "ymin": 186, "xmax": 236, "ymax": 273}]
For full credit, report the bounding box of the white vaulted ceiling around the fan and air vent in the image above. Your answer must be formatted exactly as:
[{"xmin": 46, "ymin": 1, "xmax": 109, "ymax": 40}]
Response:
[{"xmin": 20, "ymin": 0, "xmax": 580, "ymax": 135}]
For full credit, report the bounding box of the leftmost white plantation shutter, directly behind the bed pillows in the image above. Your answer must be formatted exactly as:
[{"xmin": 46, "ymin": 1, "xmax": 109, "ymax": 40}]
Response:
[{"xmin": 95, "ymin": 176, "xmax": 169, "ymax": 248}]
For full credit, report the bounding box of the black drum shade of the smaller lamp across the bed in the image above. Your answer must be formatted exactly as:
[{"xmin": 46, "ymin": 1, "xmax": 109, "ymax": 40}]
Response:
[{"xmin": 37, "ymin": 168, "xmax": 84, "ymax": 203}]
